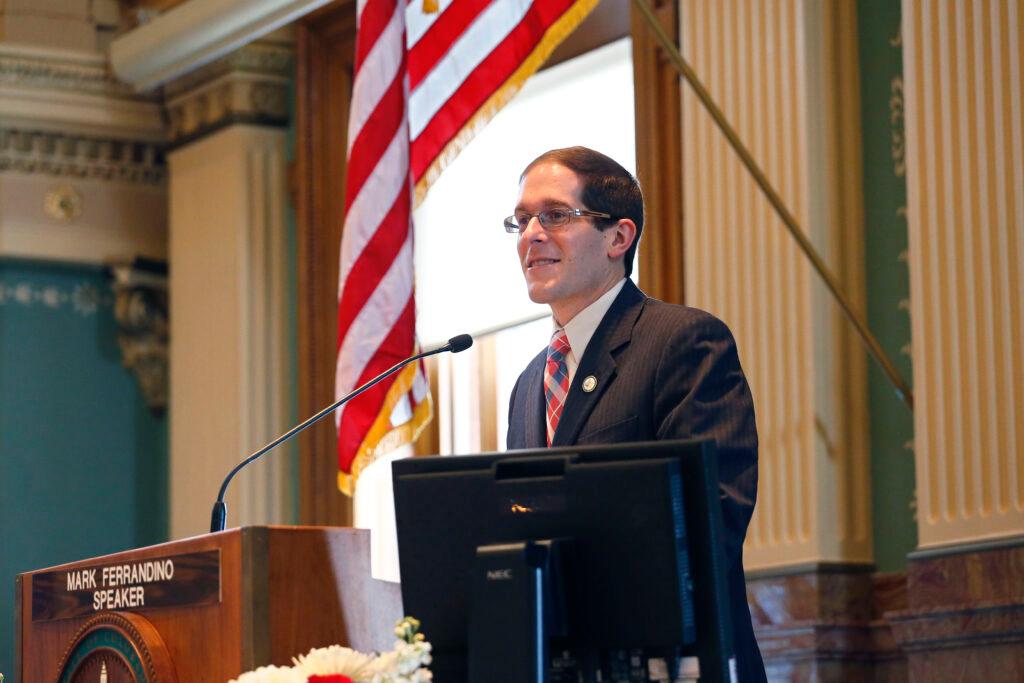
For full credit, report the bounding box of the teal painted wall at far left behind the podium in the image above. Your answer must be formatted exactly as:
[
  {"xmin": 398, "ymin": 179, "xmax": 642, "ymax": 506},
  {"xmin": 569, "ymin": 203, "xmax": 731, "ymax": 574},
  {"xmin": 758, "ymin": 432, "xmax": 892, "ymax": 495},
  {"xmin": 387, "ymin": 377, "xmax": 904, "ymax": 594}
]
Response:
[{"xmin": 0, "ymin": 259, "xmax": 168, "ymax": 681}]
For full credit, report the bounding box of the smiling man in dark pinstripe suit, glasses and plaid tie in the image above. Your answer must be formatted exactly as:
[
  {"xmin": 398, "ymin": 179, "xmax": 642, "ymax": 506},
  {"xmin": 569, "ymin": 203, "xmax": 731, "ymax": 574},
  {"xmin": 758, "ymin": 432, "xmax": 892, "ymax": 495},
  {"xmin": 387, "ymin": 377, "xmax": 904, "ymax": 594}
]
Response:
[{"xmin": 505, "ymin": 147, "xmax": 765, "ymax": 681}]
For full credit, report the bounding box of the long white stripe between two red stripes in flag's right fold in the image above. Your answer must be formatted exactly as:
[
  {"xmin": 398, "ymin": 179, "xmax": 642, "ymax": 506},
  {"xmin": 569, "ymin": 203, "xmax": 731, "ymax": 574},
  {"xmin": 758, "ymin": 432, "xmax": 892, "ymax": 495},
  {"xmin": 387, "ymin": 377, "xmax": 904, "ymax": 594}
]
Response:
[{"xmin": 409, "ymin": 0, "xmax": 532, "ymax": 141}]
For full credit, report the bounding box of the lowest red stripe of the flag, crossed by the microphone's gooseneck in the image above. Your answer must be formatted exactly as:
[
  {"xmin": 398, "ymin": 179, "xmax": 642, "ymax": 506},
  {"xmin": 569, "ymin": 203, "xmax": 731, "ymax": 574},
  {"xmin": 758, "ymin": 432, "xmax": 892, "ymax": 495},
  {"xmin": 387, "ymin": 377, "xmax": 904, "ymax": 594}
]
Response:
[{"xmin": 338, "ymin": 297, "xmax": 416, "ymax": 464}]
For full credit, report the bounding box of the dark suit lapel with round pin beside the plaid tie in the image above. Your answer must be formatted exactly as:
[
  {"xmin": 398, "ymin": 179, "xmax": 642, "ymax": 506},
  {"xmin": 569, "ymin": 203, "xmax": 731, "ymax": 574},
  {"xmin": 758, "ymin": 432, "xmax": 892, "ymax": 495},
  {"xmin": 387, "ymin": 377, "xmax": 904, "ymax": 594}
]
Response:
[{"xmin": 552, "ymin": 280, "xmax": 645, "ymax": 445}]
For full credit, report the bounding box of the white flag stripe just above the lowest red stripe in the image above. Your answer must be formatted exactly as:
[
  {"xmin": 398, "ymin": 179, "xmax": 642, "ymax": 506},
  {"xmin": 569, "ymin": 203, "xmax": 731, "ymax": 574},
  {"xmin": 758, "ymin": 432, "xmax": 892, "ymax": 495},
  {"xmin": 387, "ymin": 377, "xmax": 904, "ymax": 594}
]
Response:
[{"xmin": 335, "ymin": 230, "xmax": 413, "ymax": 423}]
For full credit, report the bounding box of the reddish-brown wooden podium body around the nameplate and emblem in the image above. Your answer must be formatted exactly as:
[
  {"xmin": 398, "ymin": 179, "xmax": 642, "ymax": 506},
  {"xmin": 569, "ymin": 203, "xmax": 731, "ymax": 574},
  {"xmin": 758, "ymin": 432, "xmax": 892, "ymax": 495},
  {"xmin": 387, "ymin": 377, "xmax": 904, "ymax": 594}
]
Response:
[{"xmin": 15, "ymin": 526, "xmax": 401, "ymax": 683}]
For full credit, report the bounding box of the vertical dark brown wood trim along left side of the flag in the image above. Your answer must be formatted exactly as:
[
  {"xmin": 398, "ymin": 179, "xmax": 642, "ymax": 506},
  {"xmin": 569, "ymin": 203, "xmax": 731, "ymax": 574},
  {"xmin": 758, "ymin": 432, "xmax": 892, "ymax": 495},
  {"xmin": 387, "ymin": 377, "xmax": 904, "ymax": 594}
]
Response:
[{"xmin": 293, "ymin": 0, "xmax": 355, "ymax": 525}]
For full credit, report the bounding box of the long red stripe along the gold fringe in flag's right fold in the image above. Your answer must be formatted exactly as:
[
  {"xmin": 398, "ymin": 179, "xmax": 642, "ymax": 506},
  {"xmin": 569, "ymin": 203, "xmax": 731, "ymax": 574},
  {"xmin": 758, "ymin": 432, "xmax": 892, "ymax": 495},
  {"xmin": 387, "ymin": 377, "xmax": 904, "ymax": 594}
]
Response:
[{"xmin": 410, "ymin": 0, "xmax": 573, "ymax": 182}]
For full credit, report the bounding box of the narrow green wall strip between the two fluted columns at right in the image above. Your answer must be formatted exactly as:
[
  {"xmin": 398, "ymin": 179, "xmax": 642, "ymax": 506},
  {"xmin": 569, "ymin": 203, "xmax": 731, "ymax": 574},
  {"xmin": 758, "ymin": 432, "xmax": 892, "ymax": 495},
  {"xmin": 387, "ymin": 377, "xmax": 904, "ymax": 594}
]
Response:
[{"xmin": 857, "ymin": 0, "xmax": 918, "ymax": 571}]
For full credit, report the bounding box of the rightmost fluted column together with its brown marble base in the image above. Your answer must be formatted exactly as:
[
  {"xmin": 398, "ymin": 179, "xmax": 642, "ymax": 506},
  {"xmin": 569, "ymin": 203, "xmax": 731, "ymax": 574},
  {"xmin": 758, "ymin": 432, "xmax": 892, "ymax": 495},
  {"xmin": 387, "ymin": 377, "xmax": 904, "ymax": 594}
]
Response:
[{"xmin": 889, "ymin": 5, "xmax": 1024, "ymax": 681}]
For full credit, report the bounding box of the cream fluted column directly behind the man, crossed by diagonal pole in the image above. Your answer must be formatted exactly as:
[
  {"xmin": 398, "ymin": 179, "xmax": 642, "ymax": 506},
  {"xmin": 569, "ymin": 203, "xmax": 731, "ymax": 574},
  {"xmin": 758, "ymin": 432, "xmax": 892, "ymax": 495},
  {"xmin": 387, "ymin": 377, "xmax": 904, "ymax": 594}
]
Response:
[{"xmin": 682, "ymin": 0, "xmax": 871, "ymax": 570}]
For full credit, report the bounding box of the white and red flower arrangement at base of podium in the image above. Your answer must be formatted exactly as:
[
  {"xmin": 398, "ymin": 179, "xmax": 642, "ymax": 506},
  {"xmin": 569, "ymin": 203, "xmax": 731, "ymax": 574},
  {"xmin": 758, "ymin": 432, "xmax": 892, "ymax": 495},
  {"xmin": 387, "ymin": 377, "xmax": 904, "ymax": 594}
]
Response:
[{"xmin": 228, "ymin": 616, "xmax": 433, "ymax": 683}]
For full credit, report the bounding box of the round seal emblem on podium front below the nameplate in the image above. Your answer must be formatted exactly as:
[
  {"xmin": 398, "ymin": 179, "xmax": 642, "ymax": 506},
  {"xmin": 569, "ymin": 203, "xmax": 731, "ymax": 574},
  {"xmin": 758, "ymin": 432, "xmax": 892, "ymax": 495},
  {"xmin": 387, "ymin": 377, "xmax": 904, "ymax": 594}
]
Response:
[{"xmin": 57, "ymin": 612, "xmax": 177, "ymax": 683}]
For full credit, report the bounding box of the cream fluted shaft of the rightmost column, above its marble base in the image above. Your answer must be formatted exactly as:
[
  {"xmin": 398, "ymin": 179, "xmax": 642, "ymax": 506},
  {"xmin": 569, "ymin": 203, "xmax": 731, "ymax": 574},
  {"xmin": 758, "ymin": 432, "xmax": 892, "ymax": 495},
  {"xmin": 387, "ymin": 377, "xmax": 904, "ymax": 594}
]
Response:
[{"xmin": 903, "ymin": 0, "xmax": 1024, "ymax": 548}]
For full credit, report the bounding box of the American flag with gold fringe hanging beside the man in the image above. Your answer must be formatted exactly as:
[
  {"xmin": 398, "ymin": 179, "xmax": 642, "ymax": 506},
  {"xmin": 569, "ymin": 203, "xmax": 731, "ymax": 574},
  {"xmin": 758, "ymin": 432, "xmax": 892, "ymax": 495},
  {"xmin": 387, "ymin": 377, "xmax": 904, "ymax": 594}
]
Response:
[{"xmin": 335, "ymin": 0, "xmax": 598, "ymax": 495}]
